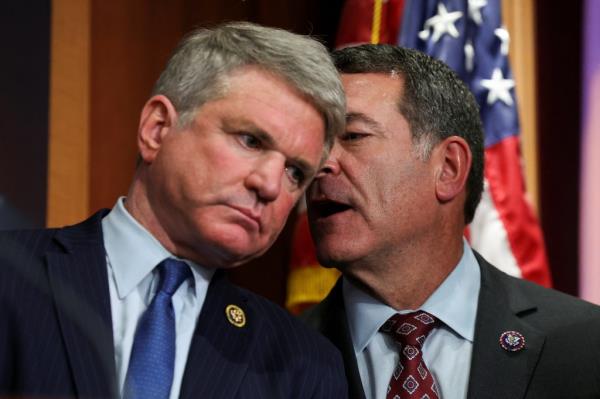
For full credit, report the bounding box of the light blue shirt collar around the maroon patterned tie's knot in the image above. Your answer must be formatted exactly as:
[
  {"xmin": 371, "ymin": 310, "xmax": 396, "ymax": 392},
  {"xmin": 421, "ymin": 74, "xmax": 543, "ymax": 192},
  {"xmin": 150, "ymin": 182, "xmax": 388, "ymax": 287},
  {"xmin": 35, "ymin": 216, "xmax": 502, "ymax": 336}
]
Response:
[{"xmin": 342, "ymin": 240, "xmax": 481, "ymax": 353}]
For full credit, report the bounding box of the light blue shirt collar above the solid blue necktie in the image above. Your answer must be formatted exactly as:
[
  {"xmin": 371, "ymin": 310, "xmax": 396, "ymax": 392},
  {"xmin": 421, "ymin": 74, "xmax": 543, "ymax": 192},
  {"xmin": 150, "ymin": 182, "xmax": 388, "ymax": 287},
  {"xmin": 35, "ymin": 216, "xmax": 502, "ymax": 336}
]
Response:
[{"xmin": 102, "ymin": 197, "xmax": 214, "ymax": 299}]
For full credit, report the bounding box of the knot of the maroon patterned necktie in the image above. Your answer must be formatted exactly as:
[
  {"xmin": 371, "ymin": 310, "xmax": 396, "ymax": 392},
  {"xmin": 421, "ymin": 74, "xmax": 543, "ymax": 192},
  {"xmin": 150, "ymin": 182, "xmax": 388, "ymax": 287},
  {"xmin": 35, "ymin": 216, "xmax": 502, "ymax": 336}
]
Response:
[{"xmin": 380, "ymin": 311, "xmax": 438, "ymax": 347}]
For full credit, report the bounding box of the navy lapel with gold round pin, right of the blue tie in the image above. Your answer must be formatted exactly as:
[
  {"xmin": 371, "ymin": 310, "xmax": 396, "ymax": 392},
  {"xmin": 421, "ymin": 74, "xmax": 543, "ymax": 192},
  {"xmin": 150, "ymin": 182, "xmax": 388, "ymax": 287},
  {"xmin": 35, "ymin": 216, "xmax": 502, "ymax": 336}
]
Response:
[{"xmin": 180, "ymin": 271, "xmax": 262, "ymax": 399}]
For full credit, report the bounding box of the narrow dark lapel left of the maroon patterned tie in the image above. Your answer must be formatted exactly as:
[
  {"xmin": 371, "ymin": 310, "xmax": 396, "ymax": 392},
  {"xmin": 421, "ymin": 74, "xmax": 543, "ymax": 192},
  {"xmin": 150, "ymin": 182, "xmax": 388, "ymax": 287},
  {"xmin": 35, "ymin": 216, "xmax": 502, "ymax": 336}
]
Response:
[{"xmin": 314, "ymin": 278, "xmax": 365, "ymax": 399}]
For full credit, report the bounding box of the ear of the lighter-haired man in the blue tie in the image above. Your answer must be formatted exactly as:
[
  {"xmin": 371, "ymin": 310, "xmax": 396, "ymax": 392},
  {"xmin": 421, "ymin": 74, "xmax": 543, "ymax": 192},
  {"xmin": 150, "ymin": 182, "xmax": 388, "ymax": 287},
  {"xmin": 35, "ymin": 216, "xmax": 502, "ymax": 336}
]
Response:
[{"xmin": 137, "ymin": 95, "xmax": 177, "ymax": 163}]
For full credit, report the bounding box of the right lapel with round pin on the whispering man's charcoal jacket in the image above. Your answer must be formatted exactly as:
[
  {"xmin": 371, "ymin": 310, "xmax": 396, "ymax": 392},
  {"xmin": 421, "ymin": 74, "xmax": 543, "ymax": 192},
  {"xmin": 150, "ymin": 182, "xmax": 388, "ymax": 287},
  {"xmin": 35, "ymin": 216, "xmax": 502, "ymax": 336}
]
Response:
[{"xmin": 467, "ymin": 256, "xmax": 545, "ymax": 399}]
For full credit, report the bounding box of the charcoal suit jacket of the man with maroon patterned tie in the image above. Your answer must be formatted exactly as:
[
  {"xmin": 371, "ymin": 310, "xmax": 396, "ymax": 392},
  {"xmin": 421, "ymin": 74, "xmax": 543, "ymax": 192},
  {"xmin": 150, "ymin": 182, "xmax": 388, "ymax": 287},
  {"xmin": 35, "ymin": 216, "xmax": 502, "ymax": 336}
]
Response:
[{"xmin": 303, "ymin": 254, "xmax": 600, "ymax": 399}]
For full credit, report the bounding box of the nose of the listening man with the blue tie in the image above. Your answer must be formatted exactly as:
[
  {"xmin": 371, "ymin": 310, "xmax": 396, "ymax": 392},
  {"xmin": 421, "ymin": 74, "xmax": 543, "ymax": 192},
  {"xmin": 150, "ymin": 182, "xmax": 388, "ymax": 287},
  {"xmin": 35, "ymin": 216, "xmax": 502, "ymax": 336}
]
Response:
[{"xmin": 246, "ymin": 155, "xmax": 285, "ymax": 202}]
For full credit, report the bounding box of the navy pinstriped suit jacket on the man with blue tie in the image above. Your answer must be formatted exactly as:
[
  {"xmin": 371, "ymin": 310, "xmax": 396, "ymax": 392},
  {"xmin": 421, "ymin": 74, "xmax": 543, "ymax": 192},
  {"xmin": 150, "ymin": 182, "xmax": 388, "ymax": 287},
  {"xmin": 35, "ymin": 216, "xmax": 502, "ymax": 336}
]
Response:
[{"xmin": 0, "ymin": 213, "xmax": 346, "ymax": 398}]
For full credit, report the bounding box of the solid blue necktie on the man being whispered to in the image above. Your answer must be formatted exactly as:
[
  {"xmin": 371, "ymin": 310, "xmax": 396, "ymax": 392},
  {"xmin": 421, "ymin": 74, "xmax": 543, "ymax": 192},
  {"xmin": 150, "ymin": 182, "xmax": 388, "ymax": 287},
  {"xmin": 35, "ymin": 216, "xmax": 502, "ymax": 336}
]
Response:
[{"xmin": 123, "ymin": 259, "xmax": 192, "ymax": 399}]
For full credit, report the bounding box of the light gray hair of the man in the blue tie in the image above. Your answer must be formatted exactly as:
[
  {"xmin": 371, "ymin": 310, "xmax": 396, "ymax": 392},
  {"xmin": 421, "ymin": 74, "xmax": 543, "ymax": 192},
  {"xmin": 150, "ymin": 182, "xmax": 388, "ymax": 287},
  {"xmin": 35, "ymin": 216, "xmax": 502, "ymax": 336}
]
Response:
[{"xmin": 152, "ymin": 22, "xmax": 346, "ymax": 151}]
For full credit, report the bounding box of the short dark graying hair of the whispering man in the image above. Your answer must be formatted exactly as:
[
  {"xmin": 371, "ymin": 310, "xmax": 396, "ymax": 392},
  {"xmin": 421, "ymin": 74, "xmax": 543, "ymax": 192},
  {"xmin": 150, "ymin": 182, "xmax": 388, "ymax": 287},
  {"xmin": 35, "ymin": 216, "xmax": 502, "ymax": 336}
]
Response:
[{"xmin": 332, "ymin": 44, "xmax": 483, "ymax": 224}]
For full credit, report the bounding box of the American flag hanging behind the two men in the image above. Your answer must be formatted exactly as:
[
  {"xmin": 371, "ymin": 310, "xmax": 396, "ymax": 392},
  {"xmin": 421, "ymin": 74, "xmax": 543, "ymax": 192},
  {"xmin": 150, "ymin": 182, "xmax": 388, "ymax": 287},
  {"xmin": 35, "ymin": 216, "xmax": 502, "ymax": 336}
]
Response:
[{"xmin": 288, "ymin": 0, "xmax": 551, "ymax": 312}]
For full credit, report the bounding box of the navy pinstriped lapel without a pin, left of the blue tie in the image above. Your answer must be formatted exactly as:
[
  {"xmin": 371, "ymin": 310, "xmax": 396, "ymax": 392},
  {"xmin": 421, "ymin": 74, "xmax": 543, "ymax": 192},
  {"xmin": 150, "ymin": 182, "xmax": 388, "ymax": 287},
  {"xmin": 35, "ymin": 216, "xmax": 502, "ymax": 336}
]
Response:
[{"xmin": 46, "ymin": 213, "xmax": 117, "ymax": 397}]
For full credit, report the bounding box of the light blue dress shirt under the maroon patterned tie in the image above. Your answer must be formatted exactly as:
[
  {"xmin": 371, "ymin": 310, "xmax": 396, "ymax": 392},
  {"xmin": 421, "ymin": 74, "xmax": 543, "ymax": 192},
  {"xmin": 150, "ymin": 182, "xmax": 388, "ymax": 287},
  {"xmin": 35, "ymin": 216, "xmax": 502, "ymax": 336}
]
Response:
[{"xmin": 343, "ymin": 241, "xmax": 481, "ymax": 399}]
